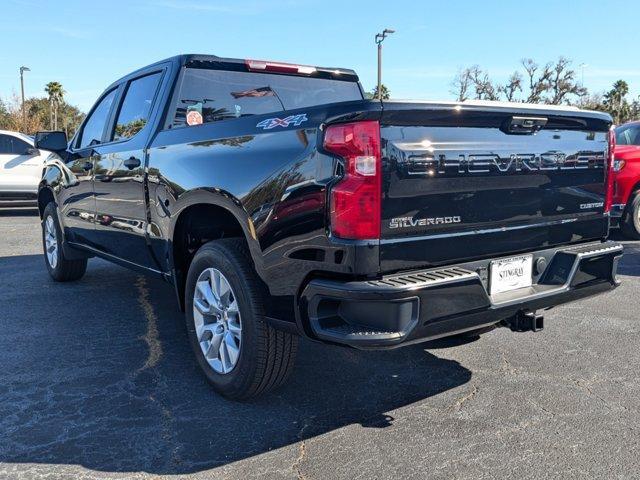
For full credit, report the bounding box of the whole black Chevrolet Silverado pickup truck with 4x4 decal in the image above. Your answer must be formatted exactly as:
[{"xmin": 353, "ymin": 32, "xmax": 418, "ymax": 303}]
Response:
[{"xmin": 36, "ymin": 55, "xmax": 622, "ymax": 398}]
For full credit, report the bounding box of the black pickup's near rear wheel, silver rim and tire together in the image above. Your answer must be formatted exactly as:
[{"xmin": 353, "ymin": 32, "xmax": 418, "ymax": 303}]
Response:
[{"xmin": 185, "ymin": 238, "xmax": 298, "ymax": 399}]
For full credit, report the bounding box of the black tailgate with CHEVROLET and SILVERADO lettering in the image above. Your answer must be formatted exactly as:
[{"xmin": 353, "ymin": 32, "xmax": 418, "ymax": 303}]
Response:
[{"xmin": 380, "ymin": 102, "xmax": 611, "ymax": 272}]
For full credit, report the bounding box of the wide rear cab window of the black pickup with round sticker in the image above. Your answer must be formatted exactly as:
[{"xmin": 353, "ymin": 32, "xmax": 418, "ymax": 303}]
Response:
[{"xmin": 170, "ymin": 68, "xmax": 362, "ymax": 127}]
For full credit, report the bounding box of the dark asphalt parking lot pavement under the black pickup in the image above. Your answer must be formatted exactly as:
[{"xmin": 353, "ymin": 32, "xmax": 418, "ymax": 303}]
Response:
[{"xmin": 0, "ymin": 209, "xmax": 640, "ymax": 480}]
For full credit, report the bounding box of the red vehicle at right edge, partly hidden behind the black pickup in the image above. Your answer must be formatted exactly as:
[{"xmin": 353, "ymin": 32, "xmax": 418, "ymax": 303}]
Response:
[{"xmin": 611, "ymin": 121, "xmax": 640, "ymax": 239}]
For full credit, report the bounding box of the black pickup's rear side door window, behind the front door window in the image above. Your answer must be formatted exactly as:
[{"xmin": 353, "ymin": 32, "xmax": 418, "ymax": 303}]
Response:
[{"xmin": 111, "ymin": 72, "xmax": 162, "ymax": 140}]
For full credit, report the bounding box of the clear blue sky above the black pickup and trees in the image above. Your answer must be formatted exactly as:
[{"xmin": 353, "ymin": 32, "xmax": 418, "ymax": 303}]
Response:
[{"xmin": 5, "ymin": 0, "xmax": 640, "ymax": 110}]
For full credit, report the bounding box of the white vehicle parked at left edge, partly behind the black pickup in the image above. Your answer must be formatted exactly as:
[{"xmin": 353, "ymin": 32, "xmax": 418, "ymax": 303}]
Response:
[{"xmin": 0, "ymin": 130, "xmax": 51, "ymax": 202}]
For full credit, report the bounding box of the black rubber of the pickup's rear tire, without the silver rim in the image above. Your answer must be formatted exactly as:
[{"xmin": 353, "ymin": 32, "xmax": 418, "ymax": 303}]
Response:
[{"xmin": 185, "ymin": 238, "xmax": 298, "ymax": 400}]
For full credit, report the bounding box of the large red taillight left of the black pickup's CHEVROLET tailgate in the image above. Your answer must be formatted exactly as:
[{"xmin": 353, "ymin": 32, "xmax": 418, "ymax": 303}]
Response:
[{"xmin": 324, "ymin": 121, "xmax": 382, "ymax": 240}]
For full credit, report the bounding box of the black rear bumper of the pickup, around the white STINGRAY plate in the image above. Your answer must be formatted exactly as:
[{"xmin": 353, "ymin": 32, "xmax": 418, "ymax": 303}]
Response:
[{"xmin": 298, "ymin": 241, "xmax": 623, "ymax": 348}]
